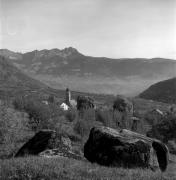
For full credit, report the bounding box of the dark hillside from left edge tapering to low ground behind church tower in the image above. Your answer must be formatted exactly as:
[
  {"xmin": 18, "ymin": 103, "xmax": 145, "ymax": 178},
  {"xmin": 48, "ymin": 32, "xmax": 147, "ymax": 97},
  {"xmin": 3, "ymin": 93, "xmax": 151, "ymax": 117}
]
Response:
[{"xmin": 0, "ymin": 56, "xmax": 114, "ymax": 104}]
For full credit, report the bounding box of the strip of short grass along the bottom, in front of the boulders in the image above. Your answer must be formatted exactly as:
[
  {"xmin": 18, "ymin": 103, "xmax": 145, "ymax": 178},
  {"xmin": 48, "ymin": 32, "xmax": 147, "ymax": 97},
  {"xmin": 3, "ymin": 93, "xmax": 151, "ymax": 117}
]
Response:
[{"xmin": 0, "ymin": 157, "xmax": 176, "ymax": 180}]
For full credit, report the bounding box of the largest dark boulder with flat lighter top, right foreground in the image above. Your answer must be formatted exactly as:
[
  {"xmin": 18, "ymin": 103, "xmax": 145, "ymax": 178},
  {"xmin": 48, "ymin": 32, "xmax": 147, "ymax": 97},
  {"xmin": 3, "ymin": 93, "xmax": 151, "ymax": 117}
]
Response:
[{"xmin": 84, "ymin": 127, "xmax": 168, "ymax": 171}]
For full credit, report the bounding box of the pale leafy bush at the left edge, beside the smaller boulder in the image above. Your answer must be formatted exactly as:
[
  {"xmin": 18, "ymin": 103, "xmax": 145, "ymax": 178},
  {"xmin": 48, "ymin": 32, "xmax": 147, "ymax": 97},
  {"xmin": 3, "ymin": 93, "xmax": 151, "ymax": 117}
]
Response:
[{"xmin": 0, "ymin": 102, "xmax": 33, "ymax": 158}]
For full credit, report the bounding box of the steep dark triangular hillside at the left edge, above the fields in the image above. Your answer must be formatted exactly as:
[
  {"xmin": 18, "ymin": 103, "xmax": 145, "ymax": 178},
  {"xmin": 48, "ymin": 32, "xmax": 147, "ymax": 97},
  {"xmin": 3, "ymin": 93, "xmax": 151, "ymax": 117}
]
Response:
[{"xmin": 0, "ymin": 56, "xmax": 56, "ymax": 97}]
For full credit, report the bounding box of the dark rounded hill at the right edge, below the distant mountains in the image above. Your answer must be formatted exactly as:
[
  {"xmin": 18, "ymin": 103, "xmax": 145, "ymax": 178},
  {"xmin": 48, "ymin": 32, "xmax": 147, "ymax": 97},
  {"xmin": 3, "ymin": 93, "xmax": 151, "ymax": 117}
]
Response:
[{"xmin": 139, "ymin": 77, "xmax": 176, "ymax": 103}]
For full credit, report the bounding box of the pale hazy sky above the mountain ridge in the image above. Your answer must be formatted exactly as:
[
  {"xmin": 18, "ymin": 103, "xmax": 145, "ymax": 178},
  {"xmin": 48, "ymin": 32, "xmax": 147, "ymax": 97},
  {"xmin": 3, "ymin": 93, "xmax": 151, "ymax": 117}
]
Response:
[{"xmin": 0, "ymin": 0, "xmax": 176, "ymax": 59}]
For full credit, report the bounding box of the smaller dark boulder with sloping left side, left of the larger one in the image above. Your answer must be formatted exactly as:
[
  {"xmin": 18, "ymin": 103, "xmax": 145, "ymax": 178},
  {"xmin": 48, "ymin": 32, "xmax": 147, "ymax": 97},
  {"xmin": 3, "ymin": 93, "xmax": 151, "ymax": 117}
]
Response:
[{"xmin": 15, "ymin": 130, "xmax": 81, "ymax": 159}]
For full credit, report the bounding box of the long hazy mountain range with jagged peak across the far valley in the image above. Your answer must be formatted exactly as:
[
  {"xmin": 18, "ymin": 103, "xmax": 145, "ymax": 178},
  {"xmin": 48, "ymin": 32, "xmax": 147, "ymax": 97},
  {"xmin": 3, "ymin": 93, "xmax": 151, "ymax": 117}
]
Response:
[{"xmin": 0, "ymin": 47, "xmax": 176, "ymax": 96}]
